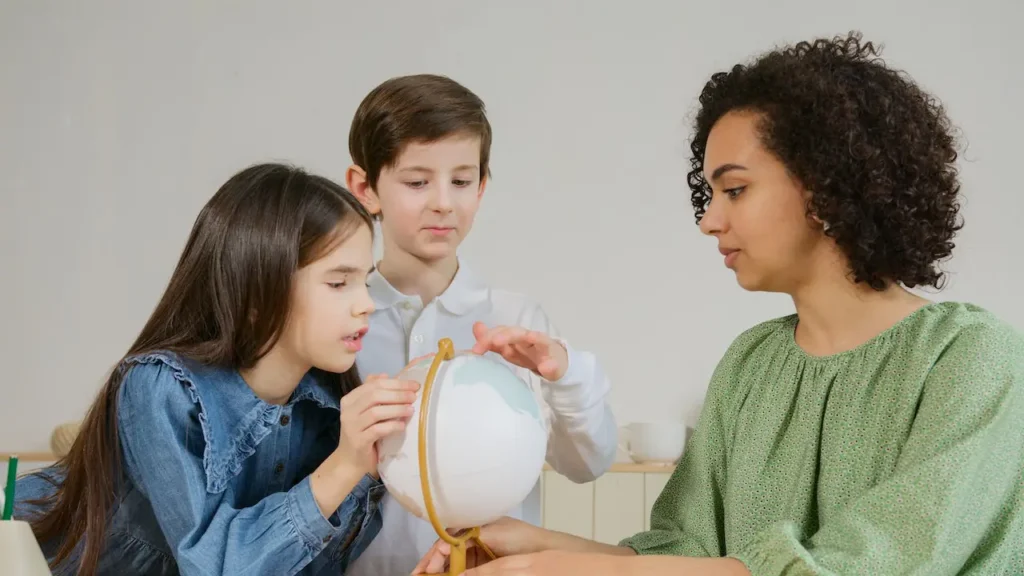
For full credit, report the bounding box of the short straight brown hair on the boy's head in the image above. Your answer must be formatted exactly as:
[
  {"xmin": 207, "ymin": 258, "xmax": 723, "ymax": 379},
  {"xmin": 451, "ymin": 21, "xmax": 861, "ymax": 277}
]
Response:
[{"xmin": 348, "ymin": 74, "xmax": 490, "ymax": 189}]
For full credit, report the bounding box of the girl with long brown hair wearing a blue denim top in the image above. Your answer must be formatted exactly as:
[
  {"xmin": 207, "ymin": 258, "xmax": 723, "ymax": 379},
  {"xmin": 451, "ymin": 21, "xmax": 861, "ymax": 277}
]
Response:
[{"xmin": 17, "ymin": 164, "xmax": 418, "ymax": 575}]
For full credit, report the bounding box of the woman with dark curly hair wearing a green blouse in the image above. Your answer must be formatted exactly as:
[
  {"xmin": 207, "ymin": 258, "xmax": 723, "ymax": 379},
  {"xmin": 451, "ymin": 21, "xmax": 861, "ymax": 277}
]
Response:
[{"xmin": 411, "ymin": 34, "xmax": 1024, "ymax": 576}]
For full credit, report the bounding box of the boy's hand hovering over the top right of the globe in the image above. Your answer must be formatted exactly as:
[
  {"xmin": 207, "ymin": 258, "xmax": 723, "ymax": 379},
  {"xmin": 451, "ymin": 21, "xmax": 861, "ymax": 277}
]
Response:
[{"xmin": 473, "ymin": 322, "xmax": 569, "ymax": 381}]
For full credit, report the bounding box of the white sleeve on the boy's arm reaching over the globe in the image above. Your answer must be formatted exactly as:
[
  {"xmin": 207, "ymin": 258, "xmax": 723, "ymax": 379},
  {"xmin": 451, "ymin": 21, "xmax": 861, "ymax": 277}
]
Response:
[{"xmin": 520, "ymin": 305, "xmax": 618, "ymax": 483}]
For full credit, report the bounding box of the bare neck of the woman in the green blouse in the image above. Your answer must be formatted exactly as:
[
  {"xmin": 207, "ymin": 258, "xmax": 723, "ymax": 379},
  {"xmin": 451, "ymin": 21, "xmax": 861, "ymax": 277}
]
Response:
[{"xmin": 793, "ymin": 259, "xmax": 929, "ymax": 356}]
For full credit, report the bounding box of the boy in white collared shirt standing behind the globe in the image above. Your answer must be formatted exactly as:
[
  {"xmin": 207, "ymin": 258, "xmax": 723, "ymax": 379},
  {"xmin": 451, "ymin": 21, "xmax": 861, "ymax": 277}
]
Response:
[{"xmin": 346, "ymin": 75, "xmax": 617, "ymax": 576}]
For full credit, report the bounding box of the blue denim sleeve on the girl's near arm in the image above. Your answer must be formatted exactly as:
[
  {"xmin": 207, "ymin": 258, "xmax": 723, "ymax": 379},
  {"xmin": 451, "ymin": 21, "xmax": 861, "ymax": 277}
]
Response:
[{"xmin": 118, "ymin": 363, "xmax": 380, "ymax": 574}]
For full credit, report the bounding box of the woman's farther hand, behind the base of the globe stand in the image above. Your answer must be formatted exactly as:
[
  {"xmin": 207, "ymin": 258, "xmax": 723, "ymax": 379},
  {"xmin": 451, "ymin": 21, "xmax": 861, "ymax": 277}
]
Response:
[{"xmin": 413, "ymin": 518, "xmax": 546, "ymax": 574}]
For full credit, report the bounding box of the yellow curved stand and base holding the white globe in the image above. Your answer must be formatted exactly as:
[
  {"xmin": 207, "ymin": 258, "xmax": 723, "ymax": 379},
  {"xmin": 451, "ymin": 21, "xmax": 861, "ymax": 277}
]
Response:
[{"xmin": 419, "ymin": 338, "xmax": 496, "ymax": 576}]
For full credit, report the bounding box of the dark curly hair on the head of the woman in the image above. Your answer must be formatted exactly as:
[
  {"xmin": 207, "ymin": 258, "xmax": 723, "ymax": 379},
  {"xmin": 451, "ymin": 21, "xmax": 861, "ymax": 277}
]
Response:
[{"xmin": 687, "ymin": 32, "xmax": 963, "ymax": 290}]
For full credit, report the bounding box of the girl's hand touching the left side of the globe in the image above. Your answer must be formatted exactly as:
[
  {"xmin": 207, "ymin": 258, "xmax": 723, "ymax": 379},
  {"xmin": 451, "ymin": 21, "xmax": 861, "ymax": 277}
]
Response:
[{"xmin": 337, "ymin": 374, "xmax": 420, "ymax": 477}]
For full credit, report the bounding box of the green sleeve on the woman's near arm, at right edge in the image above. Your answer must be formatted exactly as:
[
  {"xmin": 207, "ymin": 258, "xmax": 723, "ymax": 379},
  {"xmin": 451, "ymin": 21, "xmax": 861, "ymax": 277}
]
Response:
[{"xmin": 729, "ymin": 327, "xmax": 1024, "ymax": 576}]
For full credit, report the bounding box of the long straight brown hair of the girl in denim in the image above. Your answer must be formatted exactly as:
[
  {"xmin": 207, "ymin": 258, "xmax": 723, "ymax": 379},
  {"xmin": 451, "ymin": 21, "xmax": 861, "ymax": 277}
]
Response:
[{"xmin": 30, "ymin": 164, "xmax": 373, "ymax": 576}]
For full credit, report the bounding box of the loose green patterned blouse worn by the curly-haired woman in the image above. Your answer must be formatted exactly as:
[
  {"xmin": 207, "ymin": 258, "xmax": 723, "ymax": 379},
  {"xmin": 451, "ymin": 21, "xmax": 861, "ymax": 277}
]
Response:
[{"xmin": 622, "ymin": 302, "xmax": 1024, "ymax": 576}]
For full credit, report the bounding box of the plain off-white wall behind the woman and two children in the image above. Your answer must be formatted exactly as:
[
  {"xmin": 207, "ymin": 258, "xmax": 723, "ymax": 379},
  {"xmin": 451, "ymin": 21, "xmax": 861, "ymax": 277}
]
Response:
[{"xmin": 0, "ymin": 0, "xmax": 1024, "ymax": 450}]
